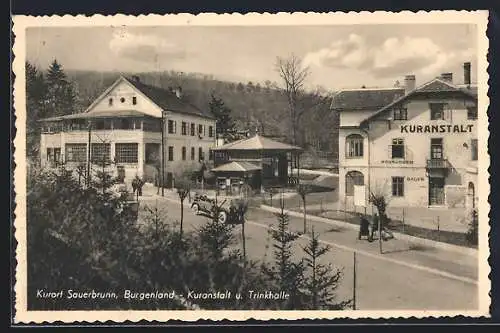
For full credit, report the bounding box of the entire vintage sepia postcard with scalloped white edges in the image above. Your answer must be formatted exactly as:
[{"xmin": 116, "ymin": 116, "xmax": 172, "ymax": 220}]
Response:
[{"xmin": 13, "ymin": 11, "xmax": 490, "ymax": 323}]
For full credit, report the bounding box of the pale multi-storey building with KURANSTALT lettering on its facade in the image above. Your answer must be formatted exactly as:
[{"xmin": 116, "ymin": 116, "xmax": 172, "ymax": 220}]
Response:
[{"xmin": 331, "ymin": 63, "xmax": 478, "ymax": 211}]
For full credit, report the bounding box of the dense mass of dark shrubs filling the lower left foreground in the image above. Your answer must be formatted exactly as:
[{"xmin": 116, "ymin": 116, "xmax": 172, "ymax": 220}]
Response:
[{"xmin": 27, "ymin": 165, "xmax": 350, "ymax": 310}]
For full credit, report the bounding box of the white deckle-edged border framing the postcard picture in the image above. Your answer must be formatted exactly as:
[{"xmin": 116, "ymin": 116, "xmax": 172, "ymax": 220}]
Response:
[{"xmin": 13, "ymin": 11, "xmax": 491, "ymax": 323}]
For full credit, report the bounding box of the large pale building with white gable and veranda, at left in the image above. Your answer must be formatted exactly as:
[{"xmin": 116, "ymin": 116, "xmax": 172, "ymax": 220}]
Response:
[{"xmin": 40, "ymin": 76, "xmax": 216, "ymax": 187}]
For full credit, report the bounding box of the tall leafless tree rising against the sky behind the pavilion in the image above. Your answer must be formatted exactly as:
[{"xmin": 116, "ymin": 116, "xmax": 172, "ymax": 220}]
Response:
[{"xmin": 276, "ymin": 54, "xmax": 309, "ymax": 144}]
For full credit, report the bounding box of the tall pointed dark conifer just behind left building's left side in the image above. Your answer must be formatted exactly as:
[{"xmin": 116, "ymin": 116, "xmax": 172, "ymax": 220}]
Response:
[{"xmin": 46, "ymin": 59, "xmax": 76, "ymax": 116}]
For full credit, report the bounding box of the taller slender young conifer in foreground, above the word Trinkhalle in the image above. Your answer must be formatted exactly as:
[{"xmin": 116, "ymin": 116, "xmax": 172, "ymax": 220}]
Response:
[{"xmin": 262, "ymin": 196, "xmax": 304, "ymax": 309}]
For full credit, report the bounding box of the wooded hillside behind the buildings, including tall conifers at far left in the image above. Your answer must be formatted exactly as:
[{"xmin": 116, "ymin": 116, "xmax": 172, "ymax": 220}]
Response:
[{"xmin": 27, "ymin": 59, "xmax": 338, "ymax": 167}]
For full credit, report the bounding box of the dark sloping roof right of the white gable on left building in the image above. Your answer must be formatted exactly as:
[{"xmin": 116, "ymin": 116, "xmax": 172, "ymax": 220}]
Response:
[{"xmin": 126, "ymin": 78, "xmax": 214, "ymax": 119}]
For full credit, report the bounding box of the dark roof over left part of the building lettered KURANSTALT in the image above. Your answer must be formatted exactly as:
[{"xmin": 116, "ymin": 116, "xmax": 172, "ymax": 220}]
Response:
[{"xmin": 331, "ymin": 88, "xmax": 405, "ymax": 111}]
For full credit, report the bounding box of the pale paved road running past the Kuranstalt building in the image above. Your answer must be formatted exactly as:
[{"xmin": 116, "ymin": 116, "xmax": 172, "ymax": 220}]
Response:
[{"xmin": 141, "ymin": 193, "xmax": 478, "ymax": 311}]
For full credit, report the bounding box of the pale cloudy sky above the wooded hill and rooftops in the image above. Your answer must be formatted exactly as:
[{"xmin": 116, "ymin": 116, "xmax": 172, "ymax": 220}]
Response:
[{"xmin": 26, "ymin": 24, "xmax": 477, "ymax": 90}]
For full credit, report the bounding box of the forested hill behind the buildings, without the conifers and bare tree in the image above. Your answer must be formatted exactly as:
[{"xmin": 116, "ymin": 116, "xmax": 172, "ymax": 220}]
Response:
[{"xmin": 66, "ymin": 70, "xmax": 338, "ymax": 157}]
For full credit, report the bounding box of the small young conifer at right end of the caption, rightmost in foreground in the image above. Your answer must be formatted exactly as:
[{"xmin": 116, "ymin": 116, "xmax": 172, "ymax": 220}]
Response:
[{"xmin": 302, "ymin": 229, "xmax": 349, "ymax": 310}]
